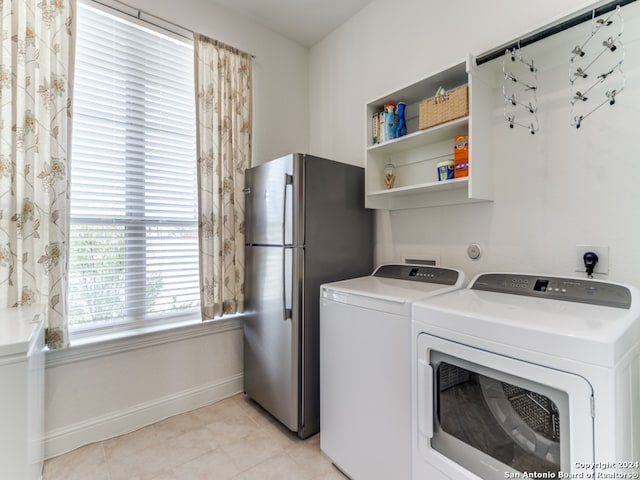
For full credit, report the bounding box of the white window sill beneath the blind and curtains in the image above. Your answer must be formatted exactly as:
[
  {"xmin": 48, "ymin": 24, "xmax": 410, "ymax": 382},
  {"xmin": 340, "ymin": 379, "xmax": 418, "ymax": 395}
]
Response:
[{"xmin": 46, "ymin": 314, "xmax": 243, "ymax": 368}]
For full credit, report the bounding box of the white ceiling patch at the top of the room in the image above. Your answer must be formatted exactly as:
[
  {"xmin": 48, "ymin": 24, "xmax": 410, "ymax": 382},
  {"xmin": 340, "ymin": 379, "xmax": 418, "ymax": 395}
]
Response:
[{"xmin": 211, "ymin": 0, "xmax": 372, "ymax": 48}]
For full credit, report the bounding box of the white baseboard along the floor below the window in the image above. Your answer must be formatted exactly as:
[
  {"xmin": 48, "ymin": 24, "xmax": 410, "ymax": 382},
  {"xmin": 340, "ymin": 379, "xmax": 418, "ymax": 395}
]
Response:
[{"xmin": 44, "ymin": 374, "xmax": 243, "ymax": 458}]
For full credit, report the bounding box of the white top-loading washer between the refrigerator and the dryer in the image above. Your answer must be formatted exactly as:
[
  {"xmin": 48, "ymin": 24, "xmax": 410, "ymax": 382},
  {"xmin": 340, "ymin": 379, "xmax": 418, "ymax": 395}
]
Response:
[{"xmin": 320, "ymin": 264, "xmax": 465, "ymax": 480}]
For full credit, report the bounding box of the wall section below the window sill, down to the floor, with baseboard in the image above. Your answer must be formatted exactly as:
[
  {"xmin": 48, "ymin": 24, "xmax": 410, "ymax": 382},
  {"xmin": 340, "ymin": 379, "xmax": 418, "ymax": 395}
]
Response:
[{"xmin": 45, "ymin": 319, "xmax": 243, "ymax": 457}]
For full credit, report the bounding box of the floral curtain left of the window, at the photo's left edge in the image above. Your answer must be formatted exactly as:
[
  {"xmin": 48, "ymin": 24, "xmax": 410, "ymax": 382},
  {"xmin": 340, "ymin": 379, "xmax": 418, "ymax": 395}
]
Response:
[{"xmin": 0, "ymin": 0, "xmax": 76, "ymax": 348}]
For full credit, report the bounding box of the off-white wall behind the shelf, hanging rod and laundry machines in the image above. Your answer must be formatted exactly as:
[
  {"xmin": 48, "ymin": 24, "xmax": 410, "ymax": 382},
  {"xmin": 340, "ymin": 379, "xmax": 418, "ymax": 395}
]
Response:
[{"xmin": 309, "ymin": 0, "xmax": 640, "ymax": 286}]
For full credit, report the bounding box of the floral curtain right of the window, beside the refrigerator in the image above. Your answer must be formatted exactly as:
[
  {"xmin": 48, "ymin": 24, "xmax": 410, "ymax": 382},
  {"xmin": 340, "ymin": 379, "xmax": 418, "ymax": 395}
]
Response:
[{"xmin": 194, "ymin": 34, "xmax": 252, "ymax": 320}]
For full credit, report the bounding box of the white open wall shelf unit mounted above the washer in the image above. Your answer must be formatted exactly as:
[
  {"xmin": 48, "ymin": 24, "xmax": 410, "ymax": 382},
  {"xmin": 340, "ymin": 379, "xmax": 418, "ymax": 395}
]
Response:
[{"xmin": 365, "ymin": 59, "xmax": 494, "ymax": 210}]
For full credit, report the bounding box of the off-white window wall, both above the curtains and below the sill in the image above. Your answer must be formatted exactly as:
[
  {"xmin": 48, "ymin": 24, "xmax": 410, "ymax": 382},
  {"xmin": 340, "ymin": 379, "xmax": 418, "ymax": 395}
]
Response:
[{"xmin": 45, "ymin": 0, "xmax": 309, "ymax": 457}]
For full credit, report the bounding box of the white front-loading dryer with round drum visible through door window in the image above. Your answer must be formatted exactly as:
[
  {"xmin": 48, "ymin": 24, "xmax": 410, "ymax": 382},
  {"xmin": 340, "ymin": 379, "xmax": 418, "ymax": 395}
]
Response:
[{"xmin": 412, "ymin": 273, "xmax": 640, "ymax": 480}]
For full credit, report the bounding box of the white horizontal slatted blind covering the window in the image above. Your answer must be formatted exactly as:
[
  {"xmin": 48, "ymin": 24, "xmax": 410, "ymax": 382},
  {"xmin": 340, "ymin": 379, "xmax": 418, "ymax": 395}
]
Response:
[{"xmin": 68, "ymin": 4, "xmax": 199, "ymax": 331}]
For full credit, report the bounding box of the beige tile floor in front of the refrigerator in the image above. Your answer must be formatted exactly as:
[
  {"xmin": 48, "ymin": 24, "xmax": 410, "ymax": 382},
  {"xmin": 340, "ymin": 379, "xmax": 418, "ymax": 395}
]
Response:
[{"xmin": 44, "ymin": 395, "xmax": 346, "ymax": 480}]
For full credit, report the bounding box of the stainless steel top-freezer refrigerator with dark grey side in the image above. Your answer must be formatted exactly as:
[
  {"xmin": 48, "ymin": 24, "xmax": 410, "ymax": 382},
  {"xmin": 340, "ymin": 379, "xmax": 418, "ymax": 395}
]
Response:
[{"xmin": 244, "ymin": 153, "xmax": 374, "ymax": 438}]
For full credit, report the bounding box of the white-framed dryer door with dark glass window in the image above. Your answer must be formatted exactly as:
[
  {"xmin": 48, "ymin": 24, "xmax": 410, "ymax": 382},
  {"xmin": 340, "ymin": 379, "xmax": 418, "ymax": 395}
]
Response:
[{"xmin": 414, "ymin": 333, "xmax": 593, "ymax": 479}]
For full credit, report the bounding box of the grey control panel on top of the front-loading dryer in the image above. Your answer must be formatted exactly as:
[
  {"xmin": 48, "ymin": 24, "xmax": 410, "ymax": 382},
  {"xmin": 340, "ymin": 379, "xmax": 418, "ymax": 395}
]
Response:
[{"xmin": 469, "ymin": 273, "xmax": 631, "ymax": 309}]
